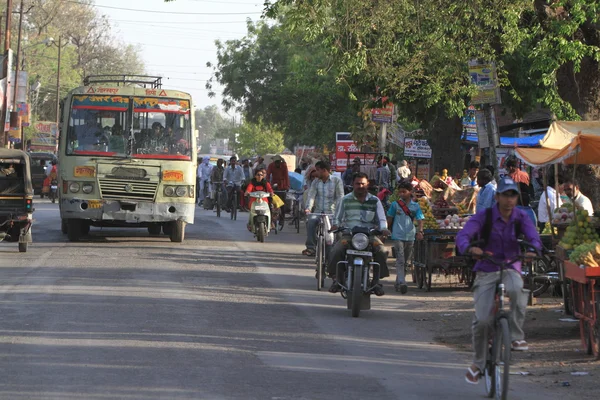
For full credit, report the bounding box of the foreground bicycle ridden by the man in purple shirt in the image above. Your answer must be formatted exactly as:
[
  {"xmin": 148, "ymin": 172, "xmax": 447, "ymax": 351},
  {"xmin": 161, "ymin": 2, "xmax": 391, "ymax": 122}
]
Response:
[{"xmin": 471, "ymin": 241, "xmax": 533, "ymax": 400}]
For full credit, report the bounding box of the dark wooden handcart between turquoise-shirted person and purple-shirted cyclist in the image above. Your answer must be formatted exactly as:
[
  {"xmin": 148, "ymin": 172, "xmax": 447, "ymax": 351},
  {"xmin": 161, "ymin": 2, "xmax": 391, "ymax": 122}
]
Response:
[{"xmin": 413, "ymin": 230, "xmax": 475, "ymax": 292}]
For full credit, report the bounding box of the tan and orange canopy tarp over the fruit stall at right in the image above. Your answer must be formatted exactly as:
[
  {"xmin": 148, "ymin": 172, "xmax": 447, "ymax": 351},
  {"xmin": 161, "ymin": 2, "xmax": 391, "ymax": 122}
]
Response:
[{"xmin": 516, "ymin": 121, "xmax": 600, "ymax": 167}]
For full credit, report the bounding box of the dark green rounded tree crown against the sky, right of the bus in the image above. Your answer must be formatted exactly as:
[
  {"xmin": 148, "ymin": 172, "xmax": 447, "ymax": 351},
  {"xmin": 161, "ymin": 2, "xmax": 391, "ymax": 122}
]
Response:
[{"xmin": 208, "ymin": 19, "xmax": 361, "ymax": 148}]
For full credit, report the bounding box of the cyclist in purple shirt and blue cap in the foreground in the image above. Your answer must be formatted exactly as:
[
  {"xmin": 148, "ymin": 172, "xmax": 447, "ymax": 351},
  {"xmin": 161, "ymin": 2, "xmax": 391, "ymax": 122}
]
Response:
[{"xmin": 456, "ymin": 177, "xmax": 542, "ymax": 384}]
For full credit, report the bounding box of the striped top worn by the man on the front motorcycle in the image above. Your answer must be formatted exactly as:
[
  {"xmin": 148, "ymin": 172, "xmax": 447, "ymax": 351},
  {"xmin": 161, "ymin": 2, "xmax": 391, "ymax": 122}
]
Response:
[{"xmin": 333, "ymin": 192, "xmax": 387, "ymax": 230}]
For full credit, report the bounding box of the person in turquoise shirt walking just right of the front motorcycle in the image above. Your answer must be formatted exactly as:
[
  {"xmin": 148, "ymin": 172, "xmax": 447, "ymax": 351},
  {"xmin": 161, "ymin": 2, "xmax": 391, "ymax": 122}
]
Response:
[{"xmin": 387, "ymin": 181, "xmax": 425, "ymax": 294}]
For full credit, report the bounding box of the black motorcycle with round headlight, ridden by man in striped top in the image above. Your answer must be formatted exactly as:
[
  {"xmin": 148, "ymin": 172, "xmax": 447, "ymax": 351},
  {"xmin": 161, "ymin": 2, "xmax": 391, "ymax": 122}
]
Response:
[{"xmin": 334, "ymin": 226, "xmax": 382, "ymax": 318}]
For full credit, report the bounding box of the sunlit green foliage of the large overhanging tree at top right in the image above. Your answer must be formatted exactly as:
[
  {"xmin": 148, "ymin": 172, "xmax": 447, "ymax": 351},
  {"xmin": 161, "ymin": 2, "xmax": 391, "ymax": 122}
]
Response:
[{"xmin": 266, "ymin": 0, "xmax": 600, "ymax": 122}]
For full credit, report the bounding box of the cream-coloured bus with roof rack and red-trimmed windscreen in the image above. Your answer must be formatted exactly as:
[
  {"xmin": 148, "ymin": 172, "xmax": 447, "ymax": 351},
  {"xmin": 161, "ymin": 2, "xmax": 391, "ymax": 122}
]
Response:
[{"xmin": 58, "ymin": 75, "xmax": 197, "ymax": 242}]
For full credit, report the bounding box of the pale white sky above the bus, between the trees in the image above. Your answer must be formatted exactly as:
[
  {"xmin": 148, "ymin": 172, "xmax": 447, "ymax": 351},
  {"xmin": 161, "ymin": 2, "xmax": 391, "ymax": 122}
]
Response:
[{"xmin": 95, "ymin": 0, "xmax": 263, "ymax": 109}]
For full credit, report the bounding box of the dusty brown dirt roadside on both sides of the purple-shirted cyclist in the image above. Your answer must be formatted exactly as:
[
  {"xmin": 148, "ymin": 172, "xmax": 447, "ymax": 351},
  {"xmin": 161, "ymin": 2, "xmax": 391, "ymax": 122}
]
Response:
[{"xmin": 387, "ymin": 277, "xmax": 600, "ymax": 399}]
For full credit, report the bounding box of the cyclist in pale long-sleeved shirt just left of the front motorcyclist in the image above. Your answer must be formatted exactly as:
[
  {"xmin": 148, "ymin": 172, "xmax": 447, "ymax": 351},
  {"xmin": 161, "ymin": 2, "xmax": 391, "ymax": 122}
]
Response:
[{"xmin": 302, "ymin": 161, "xmax": 344, "ymax": 256}]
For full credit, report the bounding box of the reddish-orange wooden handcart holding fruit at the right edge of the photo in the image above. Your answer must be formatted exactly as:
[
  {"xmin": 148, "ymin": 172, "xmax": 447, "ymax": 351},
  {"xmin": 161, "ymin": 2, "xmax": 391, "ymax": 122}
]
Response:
[{"xmin": 564, "ymin": 261, "xmax": 600, "ymax": 360}]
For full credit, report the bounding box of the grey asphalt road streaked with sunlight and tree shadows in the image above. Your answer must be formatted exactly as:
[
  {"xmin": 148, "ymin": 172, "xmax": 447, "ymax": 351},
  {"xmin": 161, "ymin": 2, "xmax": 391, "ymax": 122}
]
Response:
[{"xmin": 0, "ymin": 201, "xmax": 576, "ymax": 400}]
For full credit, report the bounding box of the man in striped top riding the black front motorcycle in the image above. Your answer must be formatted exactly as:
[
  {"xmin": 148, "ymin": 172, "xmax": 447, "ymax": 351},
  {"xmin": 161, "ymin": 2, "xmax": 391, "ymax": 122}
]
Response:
[{"xmin": 328, "ymin": 172, "xmax": 390, "ymax": 296}]
